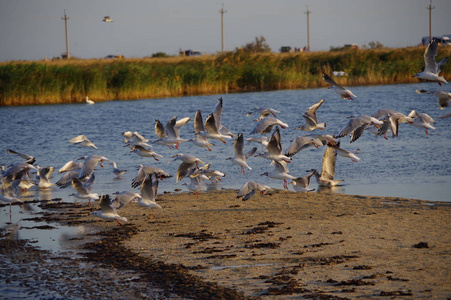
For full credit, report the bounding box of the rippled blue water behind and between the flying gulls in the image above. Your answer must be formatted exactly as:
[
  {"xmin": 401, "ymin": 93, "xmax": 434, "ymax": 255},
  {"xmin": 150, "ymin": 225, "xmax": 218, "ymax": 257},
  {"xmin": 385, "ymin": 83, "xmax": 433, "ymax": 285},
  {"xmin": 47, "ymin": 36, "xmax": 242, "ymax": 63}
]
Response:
[{"xmin": 0, "ymin": 83, "xmax": 451, "ymax": 252}]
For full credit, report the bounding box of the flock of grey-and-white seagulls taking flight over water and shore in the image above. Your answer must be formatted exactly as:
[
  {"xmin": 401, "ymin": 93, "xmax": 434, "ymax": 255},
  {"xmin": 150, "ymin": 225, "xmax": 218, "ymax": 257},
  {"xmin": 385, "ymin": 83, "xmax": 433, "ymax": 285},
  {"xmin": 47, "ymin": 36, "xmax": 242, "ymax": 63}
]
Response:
[{"xmin": 0, "ymin": 39, "xmax": 451, "ymax": 224}]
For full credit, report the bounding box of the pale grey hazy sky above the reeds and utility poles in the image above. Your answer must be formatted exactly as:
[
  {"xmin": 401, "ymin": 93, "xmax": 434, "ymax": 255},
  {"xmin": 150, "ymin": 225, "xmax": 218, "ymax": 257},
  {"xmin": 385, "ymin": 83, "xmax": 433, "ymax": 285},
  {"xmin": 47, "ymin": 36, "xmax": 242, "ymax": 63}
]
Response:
[{"xmin": 0, "ymin": 0, "xmax": 451, "ymax": 61}]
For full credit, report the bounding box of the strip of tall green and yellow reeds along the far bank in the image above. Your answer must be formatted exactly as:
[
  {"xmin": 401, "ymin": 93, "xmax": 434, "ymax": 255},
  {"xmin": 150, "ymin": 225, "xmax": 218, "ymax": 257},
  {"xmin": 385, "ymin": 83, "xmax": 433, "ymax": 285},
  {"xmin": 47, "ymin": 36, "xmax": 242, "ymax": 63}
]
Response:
[{"xmin": 0, "ymin": 47, "xmax": 451, "ymax": 106}]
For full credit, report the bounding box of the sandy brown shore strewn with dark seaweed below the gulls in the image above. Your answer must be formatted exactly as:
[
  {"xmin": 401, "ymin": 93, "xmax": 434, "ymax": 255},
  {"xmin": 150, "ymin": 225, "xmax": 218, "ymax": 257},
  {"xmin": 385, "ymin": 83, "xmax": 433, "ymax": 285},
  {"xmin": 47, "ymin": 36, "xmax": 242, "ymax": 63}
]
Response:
[{"xmin": 2, "ymin": 190, "xmax": 451, "ymax": 299}]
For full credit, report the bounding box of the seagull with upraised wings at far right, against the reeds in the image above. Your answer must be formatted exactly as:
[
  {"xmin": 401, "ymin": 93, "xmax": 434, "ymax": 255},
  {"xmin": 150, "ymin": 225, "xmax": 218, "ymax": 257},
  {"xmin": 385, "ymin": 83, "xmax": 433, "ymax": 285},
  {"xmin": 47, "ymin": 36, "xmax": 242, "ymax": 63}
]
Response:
[{"xmin": 413, "ymin": 38, "xmax": 448, "ymax": 86}]
